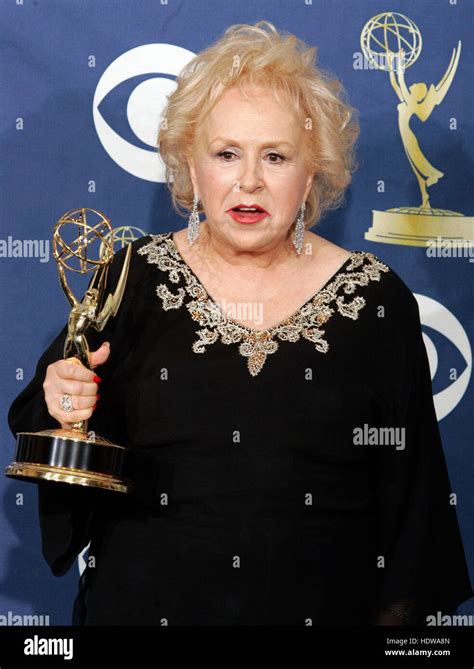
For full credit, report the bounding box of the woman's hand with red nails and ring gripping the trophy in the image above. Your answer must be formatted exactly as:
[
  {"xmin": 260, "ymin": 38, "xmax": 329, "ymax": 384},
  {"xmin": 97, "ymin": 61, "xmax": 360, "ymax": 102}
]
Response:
[{"xmin": 43, "ymin": 342, "xmax": 110, "ymax": 429}]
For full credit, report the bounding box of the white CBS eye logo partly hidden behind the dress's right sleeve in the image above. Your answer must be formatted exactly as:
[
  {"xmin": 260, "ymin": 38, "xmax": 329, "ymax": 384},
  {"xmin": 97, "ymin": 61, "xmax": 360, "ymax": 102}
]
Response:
[{"xmin": 414, "ymin": 293, "xmax": 472, "ymax": 421}]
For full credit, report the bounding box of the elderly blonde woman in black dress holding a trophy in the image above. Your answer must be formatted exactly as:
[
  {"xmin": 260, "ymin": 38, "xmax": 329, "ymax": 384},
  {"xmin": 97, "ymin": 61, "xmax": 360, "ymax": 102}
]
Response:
[{"xmin": 9, "ymin": 21, "xmax": 472, "ymax": 625}]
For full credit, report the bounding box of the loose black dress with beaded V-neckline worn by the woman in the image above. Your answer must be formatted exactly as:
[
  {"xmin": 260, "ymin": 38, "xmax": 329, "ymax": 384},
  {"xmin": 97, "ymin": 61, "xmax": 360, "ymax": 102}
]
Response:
[{"xmin": 8, "ymin": 232, "xmax": 472, "ymax": 625}]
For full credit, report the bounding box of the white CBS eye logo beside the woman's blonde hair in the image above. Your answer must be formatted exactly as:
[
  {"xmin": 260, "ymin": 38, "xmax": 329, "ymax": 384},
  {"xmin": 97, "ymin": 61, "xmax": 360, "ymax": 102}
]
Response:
[{"xmin": 93, "ymin": 44, "xmax": 195, "ymax": 183}]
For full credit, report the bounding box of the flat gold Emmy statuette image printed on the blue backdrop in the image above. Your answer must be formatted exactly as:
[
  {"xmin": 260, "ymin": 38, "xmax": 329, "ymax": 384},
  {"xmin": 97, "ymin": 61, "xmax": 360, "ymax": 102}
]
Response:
[{"xmin": 360, "ymin": 12, "xmax": 474, "ymax": 246}]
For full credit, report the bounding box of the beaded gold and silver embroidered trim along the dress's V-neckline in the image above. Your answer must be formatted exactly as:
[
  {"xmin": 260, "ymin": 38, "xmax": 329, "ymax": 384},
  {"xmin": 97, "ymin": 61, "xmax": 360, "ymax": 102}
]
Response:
[{"xmin": 137, "ymin": 232, "xmax": 389, "ymax": 376}]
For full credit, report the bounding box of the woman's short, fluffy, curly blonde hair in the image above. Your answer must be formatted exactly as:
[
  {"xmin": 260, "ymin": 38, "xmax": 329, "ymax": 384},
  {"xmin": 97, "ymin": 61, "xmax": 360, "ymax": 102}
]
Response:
[{"xmin": 158, "ymin": 21, "xmax": 360, "ymax": 228}]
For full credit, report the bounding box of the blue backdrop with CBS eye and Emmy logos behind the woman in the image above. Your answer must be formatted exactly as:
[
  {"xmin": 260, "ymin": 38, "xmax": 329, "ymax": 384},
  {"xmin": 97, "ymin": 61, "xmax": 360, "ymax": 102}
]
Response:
[{"xmin": 0, "ymin": 0, "xmax": 474, "ymax": 625}]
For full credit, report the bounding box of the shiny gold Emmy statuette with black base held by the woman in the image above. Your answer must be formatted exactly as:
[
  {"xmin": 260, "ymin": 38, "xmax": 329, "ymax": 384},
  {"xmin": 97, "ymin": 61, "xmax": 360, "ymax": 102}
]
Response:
[{"xmin": 5, "ymin": 208, "xmax": 133, "ymax": 493}]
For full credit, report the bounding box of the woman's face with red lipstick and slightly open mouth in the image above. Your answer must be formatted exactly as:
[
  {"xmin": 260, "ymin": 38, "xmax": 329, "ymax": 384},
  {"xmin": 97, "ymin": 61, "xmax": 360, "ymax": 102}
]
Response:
[{"xmin": 189, "ymin": 83, "xmax": 313, "ymax": 251}]
